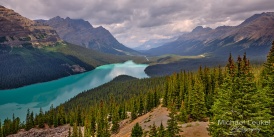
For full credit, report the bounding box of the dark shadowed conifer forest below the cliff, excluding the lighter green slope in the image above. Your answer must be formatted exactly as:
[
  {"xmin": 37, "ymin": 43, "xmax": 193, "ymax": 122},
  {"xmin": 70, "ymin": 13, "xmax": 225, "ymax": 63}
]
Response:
[{"xmin": 0, "ymin": 46, "xmax": 94, "ymax": 89}]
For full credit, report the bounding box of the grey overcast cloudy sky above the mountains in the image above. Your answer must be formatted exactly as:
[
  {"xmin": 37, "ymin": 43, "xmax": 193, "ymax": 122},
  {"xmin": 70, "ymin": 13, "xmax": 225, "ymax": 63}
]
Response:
[{"xmin": 0, "ymin": 0, "xmax": 274, "ymax": 47}]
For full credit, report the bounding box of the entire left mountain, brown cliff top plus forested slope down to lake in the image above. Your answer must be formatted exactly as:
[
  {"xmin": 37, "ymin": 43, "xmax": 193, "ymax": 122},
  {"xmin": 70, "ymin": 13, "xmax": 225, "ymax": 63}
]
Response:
[{"xmin": 0, "ymin": 6, "xmax": 145, "ymax": 89}]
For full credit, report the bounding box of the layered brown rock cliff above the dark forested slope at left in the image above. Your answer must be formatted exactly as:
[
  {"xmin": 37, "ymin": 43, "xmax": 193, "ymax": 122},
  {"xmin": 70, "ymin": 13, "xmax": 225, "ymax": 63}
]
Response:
[{"xmin": 0, "ymin": 6, "xmax": 60, "ymax": 47}]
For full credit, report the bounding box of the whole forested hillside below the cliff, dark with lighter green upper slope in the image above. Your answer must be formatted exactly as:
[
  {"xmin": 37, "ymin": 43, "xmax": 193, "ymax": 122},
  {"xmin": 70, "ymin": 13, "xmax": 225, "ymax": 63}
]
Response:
[{"xmin": 0, "ymin": 42, "xmax": 145, "ymax": 89}]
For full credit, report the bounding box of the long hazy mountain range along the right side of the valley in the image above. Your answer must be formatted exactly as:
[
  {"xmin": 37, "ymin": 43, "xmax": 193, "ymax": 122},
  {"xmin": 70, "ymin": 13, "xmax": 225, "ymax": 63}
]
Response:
[{"xmin": 148, "ymin": 12, "xmax": 274, "ymax": 56}]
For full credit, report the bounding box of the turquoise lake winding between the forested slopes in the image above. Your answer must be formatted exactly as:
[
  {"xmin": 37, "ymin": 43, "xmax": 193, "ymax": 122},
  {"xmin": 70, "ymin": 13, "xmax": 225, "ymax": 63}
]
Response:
[{"xmin": 0, "ymin": 61, "xmax": 148, "ymax": 121}]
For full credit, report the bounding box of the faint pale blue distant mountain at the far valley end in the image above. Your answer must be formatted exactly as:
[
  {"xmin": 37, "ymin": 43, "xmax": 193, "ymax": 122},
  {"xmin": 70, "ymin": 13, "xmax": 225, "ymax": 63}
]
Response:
[{"xmin": 133, "ymin": 37, "xmax": 177, "ymax": 51}]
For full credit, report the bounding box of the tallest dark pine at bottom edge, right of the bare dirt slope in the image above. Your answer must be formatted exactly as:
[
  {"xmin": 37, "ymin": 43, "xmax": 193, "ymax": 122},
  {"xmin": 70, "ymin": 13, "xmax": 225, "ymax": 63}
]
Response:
[{"xmin": 167, "ymin": 105, "xmax": 179, "ymax": 137}]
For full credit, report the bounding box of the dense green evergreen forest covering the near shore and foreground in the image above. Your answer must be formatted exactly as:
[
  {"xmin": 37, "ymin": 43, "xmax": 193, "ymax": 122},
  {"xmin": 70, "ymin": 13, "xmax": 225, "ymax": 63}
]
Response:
[{"xmin": 0, "ymin": 42, "xmax": 274, "ymax": 137}]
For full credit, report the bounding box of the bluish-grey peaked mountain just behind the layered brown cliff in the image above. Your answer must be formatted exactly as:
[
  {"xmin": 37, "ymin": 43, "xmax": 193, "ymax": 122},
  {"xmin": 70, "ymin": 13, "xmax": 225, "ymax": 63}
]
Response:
[{"xmin": 37, "ymin": 16, "xmax": 139, "ymax": 55}]
